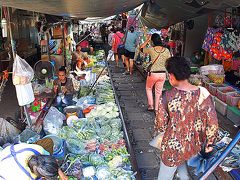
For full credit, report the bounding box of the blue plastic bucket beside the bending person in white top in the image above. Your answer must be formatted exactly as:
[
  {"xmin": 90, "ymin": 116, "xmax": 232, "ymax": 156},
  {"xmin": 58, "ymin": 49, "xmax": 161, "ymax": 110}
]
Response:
[{"xmin": 43, "ymin": 135, "xmax": 66, "ymax": 160}]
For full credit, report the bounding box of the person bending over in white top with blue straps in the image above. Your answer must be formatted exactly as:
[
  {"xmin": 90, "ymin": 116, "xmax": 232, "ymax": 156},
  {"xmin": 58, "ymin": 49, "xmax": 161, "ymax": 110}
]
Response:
[{"xmin": 0, "ymin": 143, "xmax": 68, "ymax": 180}]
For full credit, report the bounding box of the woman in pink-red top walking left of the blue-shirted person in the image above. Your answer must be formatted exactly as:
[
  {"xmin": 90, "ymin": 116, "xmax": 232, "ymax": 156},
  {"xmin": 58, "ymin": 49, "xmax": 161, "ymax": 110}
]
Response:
[{"xmin": 112, "ymin": 30, "xmax": 124, "ymax": 67}]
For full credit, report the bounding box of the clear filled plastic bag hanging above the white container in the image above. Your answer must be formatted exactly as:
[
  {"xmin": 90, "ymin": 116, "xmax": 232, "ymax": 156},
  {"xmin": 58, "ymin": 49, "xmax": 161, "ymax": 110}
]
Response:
[{"xmin": 13, "ymin": 55, "xmax": 34, "ymax": 85}]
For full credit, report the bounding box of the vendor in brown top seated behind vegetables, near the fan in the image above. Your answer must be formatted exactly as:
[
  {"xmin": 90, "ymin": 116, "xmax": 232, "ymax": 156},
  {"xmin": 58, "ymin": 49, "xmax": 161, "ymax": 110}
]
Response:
[{"xmin": 53, "ymin": 67, "xmax": 74, "ymax": 111}]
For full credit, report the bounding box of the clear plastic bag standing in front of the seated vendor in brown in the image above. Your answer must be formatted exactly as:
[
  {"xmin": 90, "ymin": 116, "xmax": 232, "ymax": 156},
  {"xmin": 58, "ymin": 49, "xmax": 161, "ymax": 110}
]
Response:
[{"xmin": 43, "ymin": 107, "xmax": 65, "ymax": 135}]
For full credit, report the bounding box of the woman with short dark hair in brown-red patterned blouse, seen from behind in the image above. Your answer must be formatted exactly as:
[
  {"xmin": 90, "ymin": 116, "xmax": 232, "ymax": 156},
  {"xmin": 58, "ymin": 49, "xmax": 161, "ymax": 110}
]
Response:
[{"xmin": 155, "ymin": 57, "xmax": 218, "ymax": 180}]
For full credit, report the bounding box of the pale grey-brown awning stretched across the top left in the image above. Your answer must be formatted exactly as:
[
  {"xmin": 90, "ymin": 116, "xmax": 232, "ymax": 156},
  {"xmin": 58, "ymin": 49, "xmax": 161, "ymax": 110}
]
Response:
[{"xmin": 0, "ymin": 0, "xmax": 146, "ymax": 18}]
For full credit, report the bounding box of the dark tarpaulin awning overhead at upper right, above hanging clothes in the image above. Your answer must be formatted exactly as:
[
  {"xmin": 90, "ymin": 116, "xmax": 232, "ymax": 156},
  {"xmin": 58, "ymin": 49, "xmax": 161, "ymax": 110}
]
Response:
[{"xmin": 142, "ymin": 0, "xmax": 240, "ymax": 28}]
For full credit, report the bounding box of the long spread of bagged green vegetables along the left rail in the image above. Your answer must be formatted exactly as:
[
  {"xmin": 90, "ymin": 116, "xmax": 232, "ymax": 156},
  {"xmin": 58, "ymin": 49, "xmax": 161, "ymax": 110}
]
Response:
[{"xmin": 4, "ymin": 51, "xmax": 137, "ymax": 180}]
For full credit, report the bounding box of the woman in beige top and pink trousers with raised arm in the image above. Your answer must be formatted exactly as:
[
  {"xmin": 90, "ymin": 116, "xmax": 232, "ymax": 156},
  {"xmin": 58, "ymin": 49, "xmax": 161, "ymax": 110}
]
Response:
[{"xmin": 140, "ymin": 33, "xmax": 171, "ymax": 111}]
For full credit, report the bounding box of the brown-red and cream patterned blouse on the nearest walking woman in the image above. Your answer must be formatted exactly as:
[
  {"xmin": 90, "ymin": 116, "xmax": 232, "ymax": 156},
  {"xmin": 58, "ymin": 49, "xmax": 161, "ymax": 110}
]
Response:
[{"xmin": 155, "ymin": 87, "xmax": 218, "ymax": 166}]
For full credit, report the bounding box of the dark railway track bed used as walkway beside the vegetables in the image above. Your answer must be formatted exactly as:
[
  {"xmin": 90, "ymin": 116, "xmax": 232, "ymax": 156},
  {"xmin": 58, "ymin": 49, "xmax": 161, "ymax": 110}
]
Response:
[{"xmin": 109, "ymin": 62, "xmax": 237, "ymax": 180}]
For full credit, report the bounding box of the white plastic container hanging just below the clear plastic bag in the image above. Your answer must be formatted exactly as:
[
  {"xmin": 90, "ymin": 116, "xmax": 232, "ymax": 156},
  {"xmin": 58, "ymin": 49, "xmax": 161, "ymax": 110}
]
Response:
[{"xmin": 15, "ymin": 83, "xmax": 35, "ymax": 106}]
